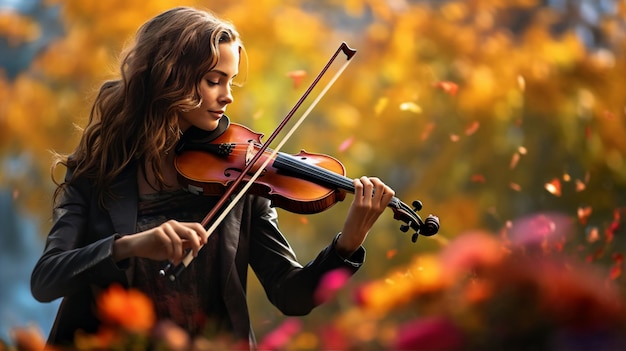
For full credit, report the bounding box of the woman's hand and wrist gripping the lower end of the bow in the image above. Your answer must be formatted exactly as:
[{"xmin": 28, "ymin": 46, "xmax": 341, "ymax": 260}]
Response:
[{"xmin": 113, "ymin": 220, "xmax": 209, "ymax": 264}]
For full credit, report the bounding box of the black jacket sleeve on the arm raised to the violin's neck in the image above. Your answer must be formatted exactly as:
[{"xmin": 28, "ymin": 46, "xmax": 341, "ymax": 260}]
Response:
[{"xmin": 250, "ymin": 198, "xmax": 365, "ymax": 315}]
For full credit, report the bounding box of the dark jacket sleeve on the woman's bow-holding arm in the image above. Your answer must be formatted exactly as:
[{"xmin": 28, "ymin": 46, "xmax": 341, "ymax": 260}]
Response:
[{"xmin": 31, "ymin": 172, "xmax": 127, "ymax": 302}]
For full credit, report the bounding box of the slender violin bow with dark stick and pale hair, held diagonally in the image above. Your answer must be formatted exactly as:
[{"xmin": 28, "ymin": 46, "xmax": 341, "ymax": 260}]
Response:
[{"xmin": 159, "ymin": 42, "xmax": 356, "ymax": 281}]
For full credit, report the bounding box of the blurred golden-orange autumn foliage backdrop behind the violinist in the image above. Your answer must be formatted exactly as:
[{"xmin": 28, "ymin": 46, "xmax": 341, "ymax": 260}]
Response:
[{"xmin": 0, "ymin": 0, "xmax": 626, "ymax": 348}]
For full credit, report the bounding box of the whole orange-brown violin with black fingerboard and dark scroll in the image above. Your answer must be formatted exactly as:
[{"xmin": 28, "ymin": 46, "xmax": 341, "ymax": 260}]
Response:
[{"xmin": 174, "ymin": 117, "xmax": 439, "ymax": 242}]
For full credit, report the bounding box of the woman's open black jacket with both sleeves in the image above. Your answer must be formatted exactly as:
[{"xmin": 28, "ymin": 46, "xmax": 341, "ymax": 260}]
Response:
[{"xmin": 31, "ymin": 165, "xmax": 365, "ymax": 347}]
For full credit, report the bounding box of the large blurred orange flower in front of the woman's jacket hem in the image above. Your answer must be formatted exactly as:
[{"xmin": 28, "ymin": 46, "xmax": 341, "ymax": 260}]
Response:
[{"xmin": 98, "ymin": 284, "xmax": 156, "ymax": 332}]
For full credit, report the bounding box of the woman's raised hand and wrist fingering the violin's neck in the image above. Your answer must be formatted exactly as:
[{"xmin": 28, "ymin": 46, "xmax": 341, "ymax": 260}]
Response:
[{"xmin": 335, "ymin": 176, "xmax": 395, "ymax": 258}]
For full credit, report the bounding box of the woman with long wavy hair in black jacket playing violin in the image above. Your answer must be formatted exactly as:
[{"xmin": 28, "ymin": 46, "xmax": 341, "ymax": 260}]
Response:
[{"xmin": 31, "ymin": 7, "xmax": 394, "ymax": 347}]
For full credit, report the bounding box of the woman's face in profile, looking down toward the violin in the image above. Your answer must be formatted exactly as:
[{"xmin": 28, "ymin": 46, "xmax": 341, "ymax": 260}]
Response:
[{"xmin": 178, "ymin": 42, "xmax": 239, "ymax": 132}]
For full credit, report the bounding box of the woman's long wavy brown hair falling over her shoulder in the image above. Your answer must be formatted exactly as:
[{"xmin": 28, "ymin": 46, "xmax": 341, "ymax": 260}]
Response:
[{"xmin": 52, "ymin": 7, "xmax": 240, "ymax": 205}]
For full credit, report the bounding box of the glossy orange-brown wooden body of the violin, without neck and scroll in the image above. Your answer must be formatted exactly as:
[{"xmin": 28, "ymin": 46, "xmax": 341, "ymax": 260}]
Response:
[{"xmin": 175, "ymin": 123, "xmax": 346, "ymax": 214}]
